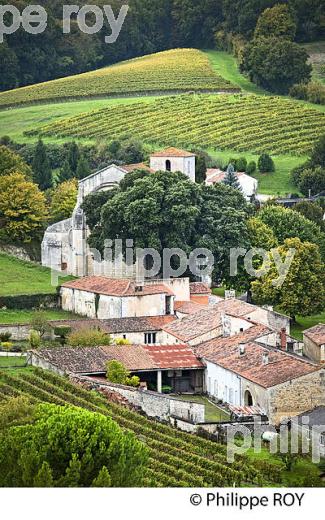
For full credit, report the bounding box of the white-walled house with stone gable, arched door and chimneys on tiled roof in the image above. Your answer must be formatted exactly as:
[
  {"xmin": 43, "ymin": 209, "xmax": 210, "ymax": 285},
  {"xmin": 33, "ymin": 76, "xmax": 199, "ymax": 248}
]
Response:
[{"xmin": 194, "ymin": 324, "xmax": 325, "ymax": 424}]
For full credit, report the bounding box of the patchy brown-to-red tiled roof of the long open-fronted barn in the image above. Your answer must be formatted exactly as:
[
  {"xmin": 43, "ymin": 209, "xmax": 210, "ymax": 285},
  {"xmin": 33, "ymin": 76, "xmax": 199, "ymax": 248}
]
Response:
[{"xmin": 34, "ymin": 345, "xmax": 204, "ymax": 374}]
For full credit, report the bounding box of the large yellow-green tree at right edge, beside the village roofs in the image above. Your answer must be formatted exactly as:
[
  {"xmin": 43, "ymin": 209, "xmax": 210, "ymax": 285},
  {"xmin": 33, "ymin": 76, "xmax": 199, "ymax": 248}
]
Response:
[{"xmin": 252, "ymin": 238, "xmax": 325, "ymax": 319}]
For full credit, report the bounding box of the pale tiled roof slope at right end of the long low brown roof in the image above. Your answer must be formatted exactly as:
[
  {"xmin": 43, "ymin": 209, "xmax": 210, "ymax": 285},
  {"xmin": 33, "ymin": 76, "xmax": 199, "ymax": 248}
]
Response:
[{"xmin": 164, "ymin": 306, "xmax": 222, "ymax": 342}]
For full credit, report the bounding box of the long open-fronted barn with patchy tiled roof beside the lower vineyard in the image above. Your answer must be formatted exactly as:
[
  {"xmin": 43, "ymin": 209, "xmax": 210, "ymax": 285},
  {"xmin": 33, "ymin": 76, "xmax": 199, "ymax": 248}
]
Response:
[{"xmin": 29, "ymin": 345, "xmax": 204, "ymax": 393}]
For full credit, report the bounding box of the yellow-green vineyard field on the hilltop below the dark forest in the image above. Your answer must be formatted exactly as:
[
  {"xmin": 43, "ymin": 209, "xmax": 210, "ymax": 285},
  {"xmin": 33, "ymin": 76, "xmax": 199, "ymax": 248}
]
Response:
[{"xmin": 0, "ymin": 49, "xmax": 236, "ymax": 107}]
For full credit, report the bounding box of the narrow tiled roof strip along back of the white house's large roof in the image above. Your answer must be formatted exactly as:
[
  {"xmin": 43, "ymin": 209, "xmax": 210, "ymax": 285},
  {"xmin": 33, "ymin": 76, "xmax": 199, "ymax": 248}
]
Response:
[{"xmin": 193, "ymin": 324, "xmax": 272, "ymax": 361}]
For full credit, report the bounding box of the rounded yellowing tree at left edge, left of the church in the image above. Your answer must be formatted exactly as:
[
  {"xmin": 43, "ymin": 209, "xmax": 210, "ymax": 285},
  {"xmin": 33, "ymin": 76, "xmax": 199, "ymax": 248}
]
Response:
[{"xmin": 0, "ymin": 173, "xmax": 48, "ymax": 243}]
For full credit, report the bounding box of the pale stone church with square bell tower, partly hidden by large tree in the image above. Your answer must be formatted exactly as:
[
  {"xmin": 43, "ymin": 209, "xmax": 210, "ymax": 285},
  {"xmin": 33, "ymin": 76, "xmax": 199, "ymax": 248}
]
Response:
[{"xmin": 42, "ymin": 148, "xmax": 196, "ymax": 278}]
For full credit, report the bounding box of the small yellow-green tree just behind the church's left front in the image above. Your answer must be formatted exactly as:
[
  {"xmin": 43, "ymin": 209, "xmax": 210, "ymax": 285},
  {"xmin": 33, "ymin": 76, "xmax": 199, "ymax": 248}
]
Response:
[{"xmin": 50, "ymin": 179, "xmax": 78, "ymax": 222}]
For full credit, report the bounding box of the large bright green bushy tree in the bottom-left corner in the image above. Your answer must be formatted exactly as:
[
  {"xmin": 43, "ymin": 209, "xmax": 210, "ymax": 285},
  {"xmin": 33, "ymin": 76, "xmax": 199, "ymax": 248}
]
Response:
[{"xmin": 0, "ymin": 404, "xmax": 148, "ymax": 487}]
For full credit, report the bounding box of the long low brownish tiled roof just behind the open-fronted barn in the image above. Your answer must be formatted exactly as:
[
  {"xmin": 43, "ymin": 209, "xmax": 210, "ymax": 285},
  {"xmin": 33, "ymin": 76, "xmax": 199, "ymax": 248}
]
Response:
[{"xmin": 49, "ymin": 316, "xmax": 177, "ymax": 334}]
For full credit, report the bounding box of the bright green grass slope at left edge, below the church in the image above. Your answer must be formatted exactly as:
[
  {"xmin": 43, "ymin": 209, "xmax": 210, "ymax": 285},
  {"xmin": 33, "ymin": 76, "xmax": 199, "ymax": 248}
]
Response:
[{"xmin": 0, "ymin": 253, "xmax": 71, "ymax": 296}]
